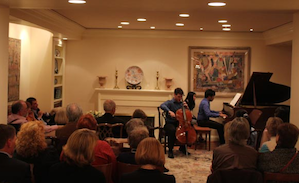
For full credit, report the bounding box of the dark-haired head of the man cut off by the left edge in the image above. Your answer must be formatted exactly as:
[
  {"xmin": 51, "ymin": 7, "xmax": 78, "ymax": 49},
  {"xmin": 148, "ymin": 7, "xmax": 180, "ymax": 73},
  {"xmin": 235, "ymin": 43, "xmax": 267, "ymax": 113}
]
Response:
[{"xmin": 0, "ymin": 124, "xmax": 16, "ymax": 155}]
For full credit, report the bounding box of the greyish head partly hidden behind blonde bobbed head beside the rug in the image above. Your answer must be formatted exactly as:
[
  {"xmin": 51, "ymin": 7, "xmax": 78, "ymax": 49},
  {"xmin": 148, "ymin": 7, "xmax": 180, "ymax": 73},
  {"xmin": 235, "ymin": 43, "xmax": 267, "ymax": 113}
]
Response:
[{"xmin": 128, "ymin": 126, "xmax": 149, "ymax": 149}]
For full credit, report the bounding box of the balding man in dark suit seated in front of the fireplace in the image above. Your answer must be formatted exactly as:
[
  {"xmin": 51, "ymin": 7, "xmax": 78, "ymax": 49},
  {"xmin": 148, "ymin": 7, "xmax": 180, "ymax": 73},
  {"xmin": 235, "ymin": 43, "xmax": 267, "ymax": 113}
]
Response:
[{"xmin": 97, "ymin": 100, "xmax": 127, "ymax": 138}]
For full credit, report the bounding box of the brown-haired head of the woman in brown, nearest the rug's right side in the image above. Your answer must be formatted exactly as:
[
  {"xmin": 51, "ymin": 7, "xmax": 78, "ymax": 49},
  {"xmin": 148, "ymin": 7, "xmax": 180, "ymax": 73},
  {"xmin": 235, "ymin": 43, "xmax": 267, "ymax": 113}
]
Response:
[{"xmin": 228, "ymin": 117, "xmax": 250, "ymax": 145}]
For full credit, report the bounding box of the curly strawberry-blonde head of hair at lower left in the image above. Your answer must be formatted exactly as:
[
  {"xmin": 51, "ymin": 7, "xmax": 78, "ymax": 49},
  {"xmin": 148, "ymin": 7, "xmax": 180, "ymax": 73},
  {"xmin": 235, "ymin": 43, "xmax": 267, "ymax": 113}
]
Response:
[{"xmin": 16, "ymin": 121, "xmax": 47, "ymax": 157}]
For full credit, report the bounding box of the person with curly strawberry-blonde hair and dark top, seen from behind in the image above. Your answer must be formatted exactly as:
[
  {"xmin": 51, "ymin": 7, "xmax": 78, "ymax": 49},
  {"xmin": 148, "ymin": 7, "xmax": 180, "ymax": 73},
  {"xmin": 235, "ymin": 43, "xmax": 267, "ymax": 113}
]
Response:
[{"xmin": 14, "ymin": 121, "xmax": 59, "ymax": 183}]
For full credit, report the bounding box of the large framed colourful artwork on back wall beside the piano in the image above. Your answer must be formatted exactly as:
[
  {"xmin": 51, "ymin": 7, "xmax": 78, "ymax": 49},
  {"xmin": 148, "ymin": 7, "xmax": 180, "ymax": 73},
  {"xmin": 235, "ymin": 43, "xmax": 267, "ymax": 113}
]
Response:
[{"xmin": 189, "ymin": 46, "xmax": 250, "ymax": 95}]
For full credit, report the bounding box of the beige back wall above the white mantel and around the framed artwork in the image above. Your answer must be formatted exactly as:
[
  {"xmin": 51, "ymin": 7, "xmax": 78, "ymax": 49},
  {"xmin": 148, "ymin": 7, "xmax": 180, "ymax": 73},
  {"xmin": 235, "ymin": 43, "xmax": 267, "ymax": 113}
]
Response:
[{"xmin": 65, "ymin": 30, "xmax": 291, "ymax": 113}]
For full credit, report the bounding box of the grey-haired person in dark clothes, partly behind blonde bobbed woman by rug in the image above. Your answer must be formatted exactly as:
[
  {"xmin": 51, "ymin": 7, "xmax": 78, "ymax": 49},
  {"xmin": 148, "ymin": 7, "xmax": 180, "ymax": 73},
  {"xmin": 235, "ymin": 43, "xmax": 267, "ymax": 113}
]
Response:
[{"xmin": 117, "ymin": 126, "xmax": 149, "ymax": 164}]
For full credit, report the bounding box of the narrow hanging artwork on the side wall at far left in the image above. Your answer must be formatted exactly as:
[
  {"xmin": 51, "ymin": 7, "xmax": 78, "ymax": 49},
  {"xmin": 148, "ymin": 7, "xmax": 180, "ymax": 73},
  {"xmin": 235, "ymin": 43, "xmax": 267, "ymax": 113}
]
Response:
[{"xmin": 8, "ymin": 38, "xmax": 21, "ymax": 102}]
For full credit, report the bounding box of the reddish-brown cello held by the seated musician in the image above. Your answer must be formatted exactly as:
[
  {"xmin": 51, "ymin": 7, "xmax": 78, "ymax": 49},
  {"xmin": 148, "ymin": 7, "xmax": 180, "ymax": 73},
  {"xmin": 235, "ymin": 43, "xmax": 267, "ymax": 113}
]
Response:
[{"xmin": 175, "ymin": 98, "xmax": 196, "ymax": 145}]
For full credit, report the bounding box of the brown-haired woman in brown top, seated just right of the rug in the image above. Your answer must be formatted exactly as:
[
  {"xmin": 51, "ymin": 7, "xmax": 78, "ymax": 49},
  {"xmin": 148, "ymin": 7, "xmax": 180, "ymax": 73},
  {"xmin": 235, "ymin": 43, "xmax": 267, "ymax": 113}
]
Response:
[{"xmin": 211, "ymin": 117, "xmax": 258, "ymax": 172}]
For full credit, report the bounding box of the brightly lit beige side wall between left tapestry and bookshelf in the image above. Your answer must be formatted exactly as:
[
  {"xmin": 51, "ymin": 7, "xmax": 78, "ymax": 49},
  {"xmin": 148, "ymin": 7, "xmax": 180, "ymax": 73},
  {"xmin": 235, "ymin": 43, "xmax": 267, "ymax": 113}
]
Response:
[{"xmin": 9, "ymin": 23, "xmax": 53, "ymax": 111}]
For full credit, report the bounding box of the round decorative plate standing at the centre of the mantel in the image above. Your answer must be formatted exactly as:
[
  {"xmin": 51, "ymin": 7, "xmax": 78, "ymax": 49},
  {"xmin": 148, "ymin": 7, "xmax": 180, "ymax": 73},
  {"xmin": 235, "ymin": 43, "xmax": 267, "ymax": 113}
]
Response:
[{"xmin": 125, "ymin": 66, "xmax": 143, "ymax": 85}]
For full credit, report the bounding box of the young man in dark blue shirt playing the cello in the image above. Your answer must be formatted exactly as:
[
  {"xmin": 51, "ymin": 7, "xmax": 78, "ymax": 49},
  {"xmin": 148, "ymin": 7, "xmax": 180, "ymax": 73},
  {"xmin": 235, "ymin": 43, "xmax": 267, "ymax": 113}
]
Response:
[{"xmin": 160, "ymin": 88, "xmax": 190, "ymax": 158}]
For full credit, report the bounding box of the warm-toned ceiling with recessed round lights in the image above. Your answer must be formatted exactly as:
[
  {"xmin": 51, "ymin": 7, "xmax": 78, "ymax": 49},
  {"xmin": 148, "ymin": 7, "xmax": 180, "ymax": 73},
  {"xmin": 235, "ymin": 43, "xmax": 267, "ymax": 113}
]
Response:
[{"xmin": 0, "ymin": 0, "xmax": 299, "ymax": 32}]
